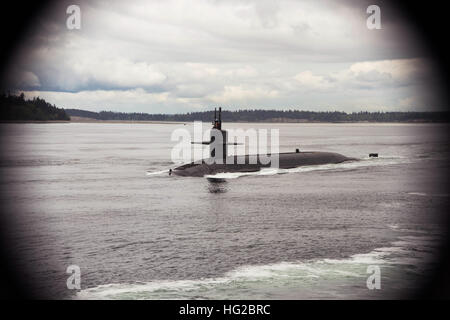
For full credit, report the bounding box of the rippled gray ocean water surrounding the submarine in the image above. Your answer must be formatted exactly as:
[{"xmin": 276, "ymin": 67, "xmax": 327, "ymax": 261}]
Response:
[{"xmin": 0, "ymin": 123, "xmax": 449, "ymax": 299}]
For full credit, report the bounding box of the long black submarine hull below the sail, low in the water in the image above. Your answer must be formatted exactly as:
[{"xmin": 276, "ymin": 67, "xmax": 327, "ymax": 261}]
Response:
[{"xmin": 172, "ymin": 151, "xmax": 356, "ymax": 177}]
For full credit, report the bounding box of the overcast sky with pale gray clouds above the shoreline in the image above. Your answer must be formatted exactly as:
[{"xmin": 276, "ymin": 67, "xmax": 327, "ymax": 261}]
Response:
[{"xmin": 3, "ymin": 0, "xmax": 445, "ymax": 113}]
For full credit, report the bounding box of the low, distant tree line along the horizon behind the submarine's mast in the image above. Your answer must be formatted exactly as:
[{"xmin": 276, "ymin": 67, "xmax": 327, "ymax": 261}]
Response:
[{"xmin": 66, "ymin": 109, "xmax": 449, "ymax": 122}]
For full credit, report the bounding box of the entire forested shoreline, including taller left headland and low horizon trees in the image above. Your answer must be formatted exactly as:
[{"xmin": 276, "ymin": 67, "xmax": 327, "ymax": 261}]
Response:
[{"xmin": 0, "ymin": 93, "xmax": 450, "ymax": 123}]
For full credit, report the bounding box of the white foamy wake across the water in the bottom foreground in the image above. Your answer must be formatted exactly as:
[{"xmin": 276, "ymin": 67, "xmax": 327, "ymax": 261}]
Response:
[{"xmin": 76, "ymin": 229, "xmax": 437, "ymax": 300}]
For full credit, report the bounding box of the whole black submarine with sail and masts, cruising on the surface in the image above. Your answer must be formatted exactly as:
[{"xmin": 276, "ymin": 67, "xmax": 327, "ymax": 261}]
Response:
[{"xmin": 169, "ymin": 108, "xmax": 356, "ymax": 177}]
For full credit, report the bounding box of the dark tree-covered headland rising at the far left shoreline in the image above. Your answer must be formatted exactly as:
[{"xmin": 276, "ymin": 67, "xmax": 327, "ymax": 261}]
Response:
[{"xmin": 0, "ymin": 93, "xmax": 70, "ymax": 121}]
